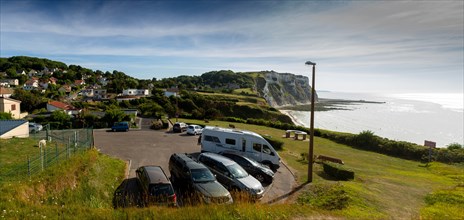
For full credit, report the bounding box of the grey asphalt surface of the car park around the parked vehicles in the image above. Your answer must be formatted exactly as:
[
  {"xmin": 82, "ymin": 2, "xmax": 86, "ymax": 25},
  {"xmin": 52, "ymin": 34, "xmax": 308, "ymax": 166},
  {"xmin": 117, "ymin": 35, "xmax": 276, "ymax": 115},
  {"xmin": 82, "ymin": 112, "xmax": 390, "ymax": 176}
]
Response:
[{"xmin": 94, "ymin": 129, "xmax": 296, "ymax": 203}]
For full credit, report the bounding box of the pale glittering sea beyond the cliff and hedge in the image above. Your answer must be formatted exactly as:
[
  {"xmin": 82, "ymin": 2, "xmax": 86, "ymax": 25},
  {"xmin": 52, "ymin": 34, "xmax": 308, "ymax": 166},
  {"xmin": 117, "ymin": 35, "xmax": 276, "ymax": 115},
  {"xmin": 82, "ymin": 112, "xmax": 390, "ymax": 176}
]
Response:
[{"xmin": 283, "ymin": 91, "xmax": 464, "ymax": 147}]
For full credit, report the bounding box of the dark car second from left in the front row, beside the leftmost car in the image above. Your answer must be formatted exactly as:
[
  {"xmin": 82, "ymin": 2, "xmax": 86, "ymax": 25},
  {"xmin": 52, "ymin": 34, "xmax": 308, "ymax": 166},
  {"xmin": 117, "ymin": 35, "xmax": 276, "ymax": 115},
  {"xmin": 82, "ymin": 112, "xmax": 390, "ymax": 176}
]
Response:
[{"xmin": 169, "ymin": 154, "xmax": 233, "ymax": 204}]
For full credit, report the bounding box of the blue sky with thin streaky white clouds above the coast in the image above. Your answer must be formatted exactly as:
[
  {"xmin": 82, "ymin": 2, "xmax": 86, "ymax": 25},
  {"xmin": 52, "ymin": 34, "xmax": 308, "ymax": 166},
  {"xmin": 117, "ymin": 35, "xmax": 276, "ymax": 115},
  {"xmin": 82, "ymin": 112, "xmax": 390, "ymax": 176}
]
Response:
[{"xmin": 0, "ymin": 0, "xmax": 464, "ymax": 93}]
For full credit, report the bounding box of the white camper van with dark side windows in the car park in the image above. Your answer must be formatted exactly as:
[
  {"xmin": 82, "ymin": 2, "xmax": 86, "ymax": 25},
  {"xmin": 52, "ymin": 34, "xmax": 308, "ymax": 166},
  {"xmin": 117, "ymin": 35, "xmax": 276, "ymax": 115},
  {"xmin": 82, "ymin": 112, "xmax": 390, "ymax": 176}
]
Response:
[{"xmin": 200, "ymin": 126, "xmax": 280, "ymax": 171}]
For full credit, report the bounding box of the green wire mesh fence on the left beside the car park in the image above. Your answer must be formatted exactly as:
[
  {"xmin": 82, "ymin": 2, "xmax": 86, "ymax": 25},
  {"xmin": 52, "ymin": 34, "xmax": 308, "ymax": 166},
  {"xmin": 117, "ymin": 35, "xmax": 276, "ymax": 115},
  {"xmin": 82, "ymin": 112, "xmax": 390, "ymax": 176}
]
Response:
[{"xmin": 0, "ymin": 125, "xmax": 93, "ymax": 180}]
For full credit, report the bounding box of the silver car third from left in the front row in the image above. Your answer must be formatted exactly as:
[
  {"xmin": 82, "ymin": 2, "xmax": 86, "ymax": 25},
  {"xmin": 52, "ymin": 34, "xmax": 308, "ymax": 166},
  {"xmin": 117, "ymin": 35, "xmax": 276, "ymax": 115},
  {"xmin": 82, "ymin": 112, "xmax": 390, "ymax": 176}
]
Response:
[{"xmin": 198, "ymin": 152, "xmax": 264, "ymax": 199}]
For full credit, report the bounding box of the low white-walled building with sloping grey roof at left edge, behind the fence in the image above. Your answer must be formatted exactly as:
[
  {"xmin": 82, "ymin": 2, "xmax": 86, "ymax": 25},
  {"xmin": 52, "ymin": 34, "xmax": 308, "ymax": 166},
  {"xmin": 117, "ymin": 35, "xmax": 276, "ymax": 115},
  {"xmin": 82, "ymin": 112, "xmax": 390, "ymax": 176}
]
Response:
[{"xmin": 0, "ymin": 120, "xmax": 29, "ymax": 139}]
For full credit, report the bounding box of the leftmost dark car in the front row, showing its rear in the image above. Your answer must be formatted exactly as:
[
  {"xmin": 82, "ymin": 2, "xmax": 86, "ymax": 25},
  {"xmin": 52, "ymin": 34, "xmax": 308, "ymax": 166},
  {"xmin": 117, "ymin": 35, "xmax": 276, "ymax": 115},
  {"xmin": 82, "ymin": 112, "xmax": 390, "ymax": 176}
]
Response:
[{"xmin": 135, "ymin": 166, "xmax": 177, "ymax": 206}]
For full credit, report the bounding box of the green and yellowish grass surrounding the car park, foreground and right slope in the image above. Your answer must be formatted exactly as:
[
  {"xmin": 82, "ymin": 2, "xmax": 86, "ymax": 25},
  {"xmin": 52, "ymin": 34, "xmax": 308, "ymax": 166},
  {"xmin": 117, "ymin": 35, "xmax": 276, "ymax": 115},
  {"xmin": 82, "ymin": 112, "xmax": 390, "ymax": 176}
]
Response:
[{"xmin": 0, "ymin": 119, "xmax": 464, "ymax": 219}]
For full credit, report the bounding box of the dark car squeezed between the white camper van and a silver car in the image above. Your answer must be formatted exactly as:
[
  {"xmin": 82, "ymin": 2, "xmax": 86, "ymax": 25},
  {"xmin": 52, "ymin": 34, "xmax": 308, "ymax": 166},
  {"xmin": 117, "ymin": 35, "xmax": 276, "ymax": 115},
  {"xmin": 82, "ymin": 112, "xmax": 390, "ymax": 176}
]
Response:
[{"xmin": 221, "ymin": 151, "xmax": 274, "ymax": 184}]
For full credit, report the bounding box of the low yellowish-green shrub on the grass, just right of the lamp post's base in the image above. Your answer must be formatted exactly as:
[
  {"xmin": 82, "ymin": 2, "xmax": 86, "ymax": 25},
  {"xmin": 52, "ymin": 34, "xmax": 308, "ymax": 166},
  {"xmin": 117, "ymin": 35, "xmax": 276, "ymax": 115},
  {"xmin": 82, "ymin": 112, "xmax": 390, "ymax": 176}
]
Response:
[{"xmin": 297, "ymin": 183, "xmax": 350, "ymax": 210}]
